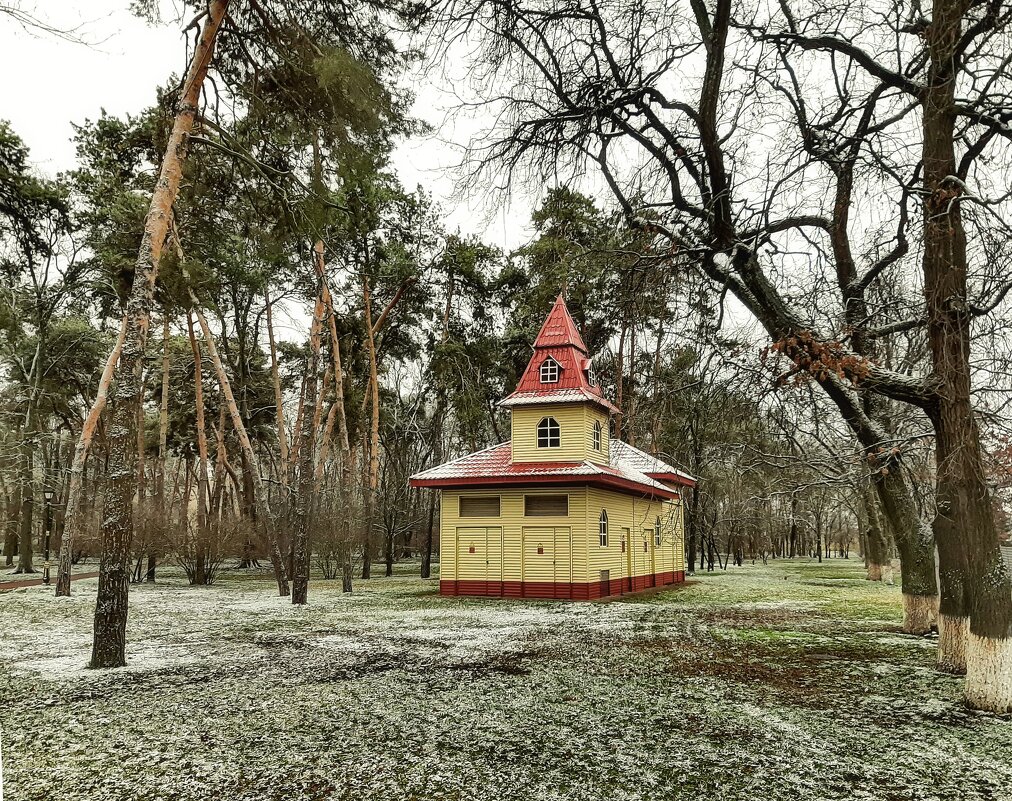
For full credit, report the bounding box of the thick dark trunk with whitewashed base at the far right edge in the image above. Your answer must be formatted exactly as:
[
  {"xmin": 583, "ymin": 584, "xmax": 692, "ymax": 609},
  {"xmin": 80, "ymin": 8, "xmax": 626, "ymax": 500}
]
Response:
[{"xmin": 922, "ymin": 0, "xmax": 1012, "ymax": 712}]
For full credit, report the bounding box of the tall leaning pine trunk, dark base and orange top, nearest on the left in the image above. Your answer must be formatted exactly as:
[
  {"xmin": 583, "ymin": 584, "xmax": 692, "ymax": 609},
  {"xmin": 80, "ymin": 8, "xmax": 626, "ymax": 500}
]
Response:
[{"xmin": 91, "ymin": 0, "xmax": 228, "ymax": 668}]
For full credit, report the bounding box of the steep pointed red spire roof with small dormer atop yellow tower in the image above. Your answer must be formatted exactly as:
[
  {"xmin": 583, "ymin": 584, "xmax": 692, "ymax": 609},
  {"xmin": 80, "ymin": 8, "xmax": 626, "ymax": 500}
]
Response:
[{"xmin": 501, "ymin": 295, "xmax": 618, "ymax": 412}]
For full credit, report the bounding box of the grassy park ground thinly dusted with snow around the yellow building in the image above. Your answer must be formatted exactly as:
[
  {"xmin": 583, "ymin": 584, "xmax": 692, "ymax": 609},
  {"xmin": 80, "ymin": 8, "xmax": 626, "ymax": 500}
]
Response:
[{"xmin": 0, "ymin": 559, "xmax": 1012, "ymax": 801}]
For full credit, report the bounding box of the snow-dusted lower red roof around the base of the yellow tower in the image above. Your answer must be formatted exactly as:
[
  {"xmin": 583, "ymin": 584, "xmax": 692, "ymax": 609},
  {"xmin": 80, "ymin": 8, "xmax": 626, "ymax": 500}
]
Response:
[{"xmin": 411, "ymin": 440, "xmax": 695, "ymax": 498}]
